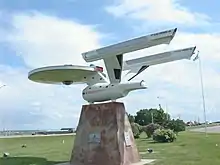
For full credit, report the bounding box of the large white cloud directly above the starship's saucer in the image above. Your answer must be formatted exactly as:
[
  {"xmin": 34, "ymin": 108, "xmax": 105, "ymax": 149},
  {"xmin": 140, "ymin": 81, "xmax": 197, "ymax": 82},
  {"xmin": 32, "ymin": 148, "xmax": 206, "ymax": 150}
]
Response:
[{"xmin": 7, "ymin": 13, "xmax": 102, "ymax": 68}]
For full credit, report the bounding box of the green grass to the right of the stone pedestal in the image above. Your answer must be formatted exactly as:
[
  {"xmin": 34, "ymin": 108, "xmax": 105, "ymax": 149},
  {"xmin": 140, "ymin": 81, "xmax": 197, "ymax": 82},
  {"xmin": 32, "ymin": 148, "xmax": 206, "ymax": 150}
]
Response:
[{"xmin": 137, "ymin": 132, "xmax": 220, "ymax": 165}]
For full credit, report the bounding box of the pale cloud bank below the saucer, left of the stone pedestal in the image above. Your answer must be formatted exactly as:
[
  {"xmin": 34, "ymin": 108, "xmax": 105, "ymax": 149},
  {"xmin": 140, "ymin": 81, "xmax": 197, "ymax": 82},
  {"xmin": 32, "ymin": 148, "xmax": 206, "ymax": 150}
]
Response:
[{"xmin": 0, "ymin": 63, "xmax": 88, "ymax": 129}]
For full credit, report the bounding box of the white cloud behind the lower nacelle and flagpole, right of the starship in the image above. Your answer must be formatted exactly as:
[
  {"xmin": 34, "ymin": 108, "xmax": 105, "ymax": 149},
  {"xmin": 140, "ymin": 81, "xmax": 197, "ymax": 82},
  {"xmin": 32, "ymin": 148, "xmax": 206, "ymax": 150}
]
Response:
[{"xmin": 121, "ymin": 32, "xmax": 220, "ymax": 120}]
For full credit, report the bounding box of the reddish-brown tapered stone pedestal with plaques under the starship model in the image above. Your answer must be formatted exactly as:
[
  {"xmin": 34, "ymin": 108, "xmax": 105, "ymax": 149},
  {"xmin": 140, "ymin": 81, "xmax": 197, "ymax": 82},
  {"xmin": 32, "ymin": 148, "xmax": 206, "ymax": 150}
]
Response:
[{"xmin": 70, "ymin": 102, "xmax": 141, "ymax": 165}]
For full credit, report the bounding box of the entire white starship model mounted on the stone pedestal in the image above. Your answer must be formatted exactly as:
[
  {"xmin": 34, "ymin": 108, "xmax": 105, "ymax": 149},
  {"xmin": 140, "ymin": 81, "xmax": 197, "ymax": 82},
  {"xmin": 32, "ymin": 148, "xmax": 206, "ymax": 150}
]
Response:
[{"xmin": 28, "ymin": 28, "xmax": 195, "ymax": 103}]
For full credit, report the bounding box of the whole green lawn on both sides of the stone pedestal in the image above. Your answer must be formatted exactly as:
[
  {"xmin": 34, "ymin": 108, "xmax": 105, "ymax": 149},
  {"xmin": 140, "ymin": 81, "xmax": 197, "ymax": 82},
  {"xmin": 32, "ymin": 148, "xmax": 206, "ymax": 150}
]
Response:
[{"xmin": 0, "ymin": 132, "xmax": 220, "ymax": 165}]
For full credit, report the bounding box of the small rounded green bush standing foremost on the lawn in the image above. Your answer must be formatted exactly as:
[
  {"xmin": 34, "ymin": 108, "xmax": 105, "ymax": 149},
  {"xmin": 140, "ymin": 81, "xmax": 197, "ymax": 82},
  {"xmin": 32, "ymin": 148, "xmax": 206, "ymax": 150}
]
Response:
[{"xmin": 153, "ymin": 129, "xmax": 176, "ymax": 143}]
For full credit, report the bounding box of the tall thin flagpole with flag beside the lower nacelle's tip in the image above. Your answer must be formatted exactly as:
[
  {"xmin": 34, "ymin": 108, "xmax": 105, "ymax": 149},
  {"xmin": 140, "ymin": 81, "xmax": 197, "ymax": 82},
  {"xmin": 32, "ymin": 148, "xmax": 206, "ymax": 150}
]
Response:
[{"xmin": 193, "ymin": 51, "xmax": 207, "ymax": 136}]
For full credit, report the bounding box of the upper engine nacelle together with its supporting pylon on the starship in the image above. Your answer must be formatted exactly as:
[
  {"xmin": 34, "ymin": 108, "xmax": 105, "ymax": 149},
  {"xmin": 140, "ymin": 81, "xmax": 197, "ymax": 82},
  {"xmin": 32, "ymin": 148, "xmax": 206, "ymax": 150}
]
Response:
[{"xmin": 82, "ymin": 28, "xmax": 177, "ymax": 83}]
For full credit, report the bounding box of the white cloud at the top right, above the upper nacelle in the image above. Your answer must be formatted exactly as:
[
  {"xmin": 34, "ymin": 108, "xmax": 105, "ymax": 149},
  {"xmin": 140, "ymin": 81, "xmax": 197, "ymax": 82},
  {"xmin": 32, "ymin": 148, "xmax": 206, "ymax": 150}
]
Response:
[{"xmin": 106, "ymin": 0, "xmax": 211, "ymax": 25}]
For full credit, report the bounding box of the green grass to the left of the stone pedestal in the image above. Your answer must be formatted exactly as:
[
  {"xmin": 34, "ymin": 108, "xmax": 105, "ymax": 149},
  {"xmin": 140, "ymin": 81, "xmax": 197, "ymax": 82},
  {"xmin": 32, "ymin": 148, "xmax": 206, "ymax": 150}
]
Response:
[{"xmin": 0, "ymin": 136, "xmax": 74, "ymax": 165}]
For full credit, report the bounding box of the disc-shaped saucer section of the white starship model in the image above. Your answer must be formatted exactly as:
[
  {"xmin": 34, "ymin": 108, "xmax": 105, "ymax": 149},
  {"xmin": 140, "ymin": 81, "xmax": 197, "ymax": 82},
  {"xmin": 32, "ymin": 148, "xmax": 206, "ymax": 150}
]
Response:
[{"xmin": 28, "ymin": 65, "xmax": 108, "ymax": 85}]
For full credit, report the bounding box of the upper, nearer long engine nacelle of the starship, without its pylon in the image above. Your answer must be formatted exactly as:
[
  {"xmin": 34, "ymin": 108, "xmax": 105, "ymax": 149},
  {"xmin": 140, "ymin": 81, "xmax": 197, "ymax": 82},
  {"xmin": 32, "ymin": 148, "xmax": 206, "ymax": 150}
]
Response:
[{"xmin": 82, "ymin": 28, "xmax": 177, "ymax": 62}]
